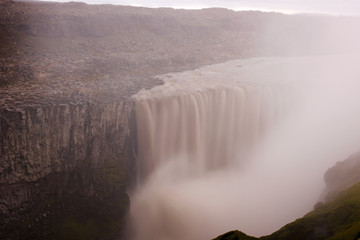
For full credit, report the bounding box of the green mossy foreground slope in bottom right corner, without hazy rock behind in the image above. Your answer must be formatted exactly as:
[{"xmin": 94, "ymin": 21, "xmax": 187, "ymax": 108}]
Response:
[{"xmin": 215, "ymin": 183, "xmax": 360, "ymax": 240}]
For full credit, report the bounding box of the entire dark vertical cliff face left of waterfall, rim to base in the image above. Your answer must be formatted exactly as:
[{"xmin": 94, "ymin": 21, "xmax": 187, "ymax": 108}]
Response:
[{"xmin": 0, "ymin": 101, "xmax": 135, "ymax": 239}]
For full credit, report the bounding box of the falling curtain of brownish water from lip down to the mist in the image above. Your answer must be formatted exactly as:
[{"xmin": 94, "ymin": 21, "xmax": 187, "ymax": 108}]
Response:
[{"xmin": 136, "ymin": 85, "xmax": 285, "ymax": 181}]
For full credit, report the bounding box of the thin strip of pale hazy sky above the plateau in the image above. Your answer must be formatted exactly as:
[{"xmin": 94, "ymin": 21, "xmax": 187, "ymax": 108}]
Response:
[{"xmin": 39, "ymin": 0, "xmax": 360, "ymax": 15}]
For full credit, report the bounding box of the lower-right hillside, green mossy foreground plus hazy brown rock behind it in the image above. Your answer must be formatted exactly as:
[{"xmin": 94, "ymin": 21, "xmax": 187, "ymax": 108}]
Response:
[{"xmin": 215, "ymin": 154, "xmax": 360, "ymax": 240}]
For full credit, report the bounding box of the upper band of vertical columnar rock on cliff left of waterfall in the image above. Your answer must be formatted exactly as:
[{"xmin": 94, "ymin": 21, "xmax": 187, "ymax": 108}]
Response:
[{"xmin": 0, "ymin": 102, "xmax": 132, "ymax": 184}]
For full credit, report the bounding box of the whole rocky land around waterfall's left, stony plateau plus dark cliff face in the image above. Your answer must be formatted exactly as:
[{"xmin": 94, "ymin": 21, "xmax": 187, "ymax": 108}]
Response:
[{"xmin": 0, "ymin": 1, "xmax": 358, "ymax": 240}]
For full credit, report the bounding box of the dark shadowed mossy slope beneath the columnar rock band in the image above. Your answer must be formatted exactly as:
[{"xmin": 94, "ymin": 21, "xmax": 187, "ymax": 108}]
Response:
[{"xmin": 0, "ymin": 164, "xmax": 130, "ymax": 240}]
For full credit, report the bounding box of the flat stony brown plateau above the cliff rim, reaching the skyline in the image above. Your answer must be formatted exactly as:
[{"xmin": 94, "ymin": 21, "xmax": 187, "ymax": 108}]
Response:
[{"xmin": 0, "ymin": 1, "xmax": 356, "ymax": 109}]
